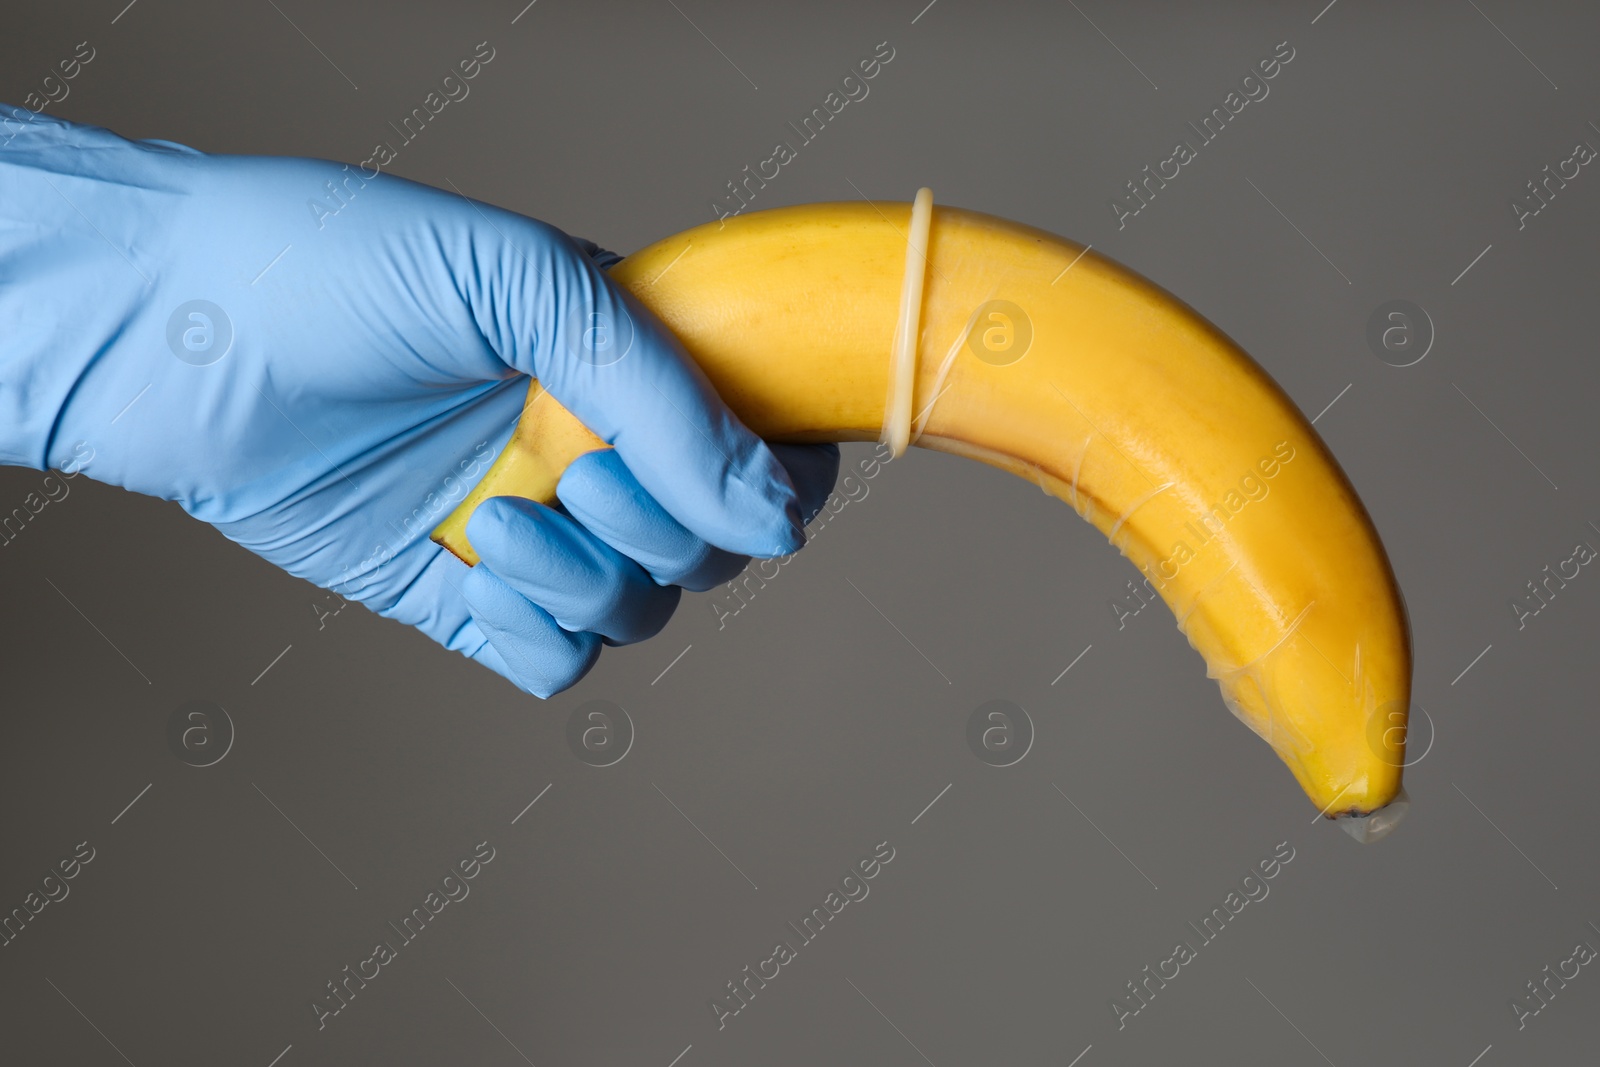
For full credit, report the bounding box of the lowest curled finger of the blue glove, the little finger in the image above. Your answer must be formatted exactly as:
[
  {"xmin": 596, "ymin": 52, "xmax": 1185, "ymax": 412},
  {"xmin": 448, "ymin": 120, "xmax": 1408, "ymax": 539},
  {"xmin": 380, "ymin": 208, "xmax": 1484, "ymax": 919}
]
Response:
[{"xmin": 461, "ymin": 563, "xmax": 600, "ymax": 699}]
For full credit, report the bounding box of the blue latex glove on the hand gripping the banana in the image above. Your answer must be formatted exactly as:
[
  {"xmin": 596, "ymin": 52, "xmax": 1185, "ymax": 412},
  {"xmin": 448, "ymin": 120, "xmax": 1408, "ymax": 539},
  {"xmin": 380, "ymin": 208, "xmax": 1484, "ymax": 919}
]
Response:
[{"xmin": 0, "ymin": 106, "xmax": 838, "ymax": 696}]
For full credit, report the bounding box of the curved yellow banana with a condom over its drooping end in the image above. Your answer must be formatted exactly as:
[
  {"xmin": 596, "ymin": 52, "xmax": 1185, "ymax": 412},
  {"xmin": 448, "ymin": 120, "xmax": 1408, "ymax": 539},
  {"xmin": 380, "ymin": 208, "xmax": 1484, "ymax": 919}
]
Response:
[{"xmin": 434, "ymin": 202, "xmax": 1411, "ymax": 840}]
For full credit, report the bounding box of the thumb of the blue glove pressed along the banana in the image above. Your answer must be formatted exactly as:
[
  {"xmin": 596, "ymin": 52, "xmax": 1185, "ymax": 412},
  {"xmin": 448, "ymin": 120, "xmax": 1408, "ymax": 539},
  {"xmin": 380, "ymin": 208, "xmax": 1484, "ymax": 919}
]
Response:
[{"xmin": 461, "ymin": 202, "xmax": 805, "ymax": 557}]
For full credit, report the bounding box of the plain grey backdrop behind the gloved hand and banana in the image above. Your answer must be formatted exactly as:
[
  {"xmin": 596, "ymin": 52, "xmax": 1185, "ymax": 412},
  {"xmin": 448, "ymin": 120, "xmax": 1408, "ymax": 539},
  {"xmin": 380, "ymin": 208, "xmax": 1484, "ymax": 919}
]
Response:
[{"xmin": 0, "ymin": 0, "xmax": 1600, "ymax": 1067}]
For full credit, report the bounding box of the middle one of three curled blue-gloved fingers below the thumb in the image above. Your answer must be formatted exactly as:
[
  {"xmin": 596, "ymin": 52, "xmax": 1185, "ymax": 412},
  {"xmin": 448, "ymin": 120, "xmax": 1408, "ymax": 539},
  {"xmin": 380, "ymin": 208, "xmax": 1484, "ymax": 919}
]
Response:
[{"xmin": 467, "ymin": 496, "xmax": 682, "ymax": 645}]
